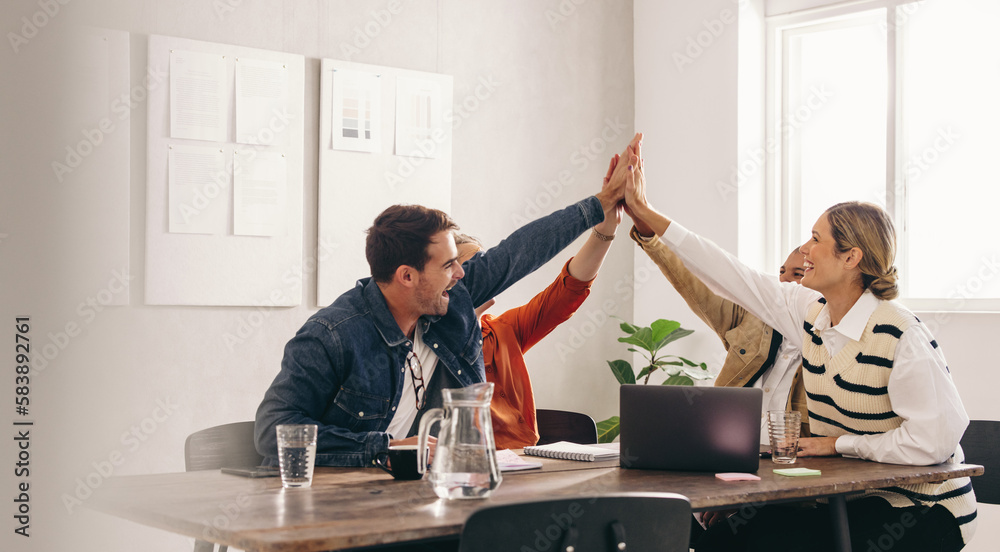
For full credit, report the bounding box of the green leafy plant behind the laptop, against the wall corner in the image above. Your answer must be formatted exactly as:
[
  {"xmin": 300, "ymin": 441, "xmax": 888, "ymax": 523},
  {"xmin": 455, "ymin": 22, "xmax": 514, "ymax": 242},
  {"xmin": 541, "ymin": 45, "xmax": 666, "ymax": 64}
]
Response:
[{"xmin": 597, "ymin": 318, "xmax": 712, "ymax": 443}]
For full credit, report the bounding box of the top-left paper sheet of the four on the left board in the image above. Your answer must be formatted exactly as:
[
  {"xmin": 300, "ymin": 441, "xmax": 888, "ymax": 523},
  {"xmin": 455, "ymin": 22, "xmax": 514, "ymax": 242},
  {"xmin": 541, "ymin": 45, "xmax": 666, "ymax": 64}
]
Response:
[{"xmin": 170, "ymin": 50, "xmax": 229, "ymax": 142}]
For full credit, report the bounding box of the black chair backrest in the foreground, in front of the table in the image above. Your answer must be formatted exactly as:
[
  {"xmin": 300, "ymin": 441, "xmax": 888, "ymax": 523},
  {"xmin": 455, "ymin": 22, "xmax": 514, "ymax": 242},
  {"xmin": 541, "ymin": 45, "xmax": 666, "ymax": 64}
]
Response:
[{"xmin": 458, "ymin": 493, "xmax": 691, "ymax": 552}]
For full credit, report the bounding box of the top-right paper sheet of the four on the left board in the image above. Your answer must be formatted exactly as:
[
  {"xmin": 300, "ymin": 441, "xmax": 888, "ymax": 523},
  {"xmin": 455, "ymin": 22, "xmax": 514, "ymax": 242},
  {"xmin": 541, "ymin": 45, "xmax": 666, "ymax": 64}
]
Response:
[{"xmin": 236, "ymin": 57, "xmax": 290, "ymax": 146}]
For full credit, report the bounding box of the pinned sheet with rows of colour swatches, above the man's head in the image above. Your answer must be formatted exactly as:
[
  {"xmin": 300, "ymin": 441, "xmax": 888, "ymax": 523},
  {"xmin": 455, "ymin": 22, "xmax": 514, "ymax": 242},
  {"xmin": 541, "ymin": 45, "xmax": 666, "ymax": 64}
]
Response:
[{"xmin": 330, "ymin": 69, "xmax": 382, "ymax": 153}]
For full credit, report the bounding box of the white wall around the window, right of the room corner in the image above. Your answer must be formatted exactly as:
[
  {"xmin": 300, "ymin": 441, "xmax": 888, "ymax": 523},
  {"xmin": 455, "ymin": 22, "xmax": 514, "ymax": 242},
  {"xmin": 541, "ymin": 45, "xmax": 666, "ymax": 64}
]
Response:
[{"xmin": 634, "ymin": 0, "xmax": 1000, "ymax": 552}]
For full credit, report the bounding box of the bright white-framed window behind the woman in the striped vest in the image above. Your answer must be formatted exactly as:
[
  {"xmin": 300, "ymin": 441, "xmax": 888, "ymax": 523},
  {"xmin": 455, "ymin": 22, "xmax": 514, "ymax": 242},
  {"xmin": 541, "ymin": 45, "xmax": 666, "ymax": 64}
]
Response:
[{"xmin": 767, "ymin": 0, "xmax": 1000, "ymax": 310}]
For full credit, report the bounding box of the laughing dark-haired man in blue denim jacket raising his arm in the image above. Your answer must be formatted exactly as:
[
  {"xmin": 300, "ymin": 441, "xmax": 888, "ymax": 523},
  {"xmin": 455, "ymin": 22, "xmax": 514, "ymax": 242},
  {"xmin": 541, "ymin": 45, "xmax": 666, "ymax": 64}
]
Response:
[{"xmin": 255, "ymin": 144, "xmax": 638, "ymax": 466}]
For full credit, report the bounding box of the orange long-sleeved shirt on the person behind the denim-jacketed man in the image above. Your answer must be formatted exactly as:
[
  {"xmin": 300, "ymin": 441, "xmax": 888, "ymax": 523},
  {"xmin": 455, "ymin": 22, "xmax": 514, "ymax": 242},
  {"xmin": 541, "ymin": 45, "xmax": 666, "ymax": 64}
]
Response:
[{"xmin": 481, "ymin": 259, "xmax": 593, "ymax": 449}]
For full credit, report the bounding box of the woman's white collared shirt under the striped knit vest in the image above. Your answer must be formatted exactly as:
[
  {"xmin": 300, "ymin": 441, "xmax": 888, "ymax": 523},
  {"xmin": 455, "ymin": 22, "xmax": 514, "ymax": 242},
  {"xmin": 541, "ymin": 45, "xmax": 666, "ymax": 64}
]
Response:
[{"xmin": 661, "ymin": 222, "xmax": 969, "ymax": 465}]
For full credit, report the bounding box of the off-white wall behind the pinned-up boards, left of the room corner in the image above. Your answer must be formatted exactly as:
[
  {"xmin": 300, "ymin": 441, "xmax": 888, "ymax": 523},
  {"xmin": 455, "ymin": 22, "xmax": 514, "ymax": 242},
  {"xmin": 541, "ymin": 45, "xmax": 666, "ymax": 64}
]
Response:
[{"xmin": 0, "ymin": 0, "xmax": 635, "ymax": 551}]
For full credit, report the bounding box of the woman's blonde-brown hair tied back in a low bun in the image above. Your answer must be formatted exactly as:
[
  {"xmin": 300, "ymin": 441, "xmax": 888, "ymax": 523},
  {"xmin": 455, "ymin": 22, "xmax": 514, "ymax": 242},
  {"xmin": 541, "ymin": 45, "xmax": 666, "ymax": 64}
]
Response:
[{"xmin": 826, "ymin": 201, "xmax": 899, "ymax": 301}]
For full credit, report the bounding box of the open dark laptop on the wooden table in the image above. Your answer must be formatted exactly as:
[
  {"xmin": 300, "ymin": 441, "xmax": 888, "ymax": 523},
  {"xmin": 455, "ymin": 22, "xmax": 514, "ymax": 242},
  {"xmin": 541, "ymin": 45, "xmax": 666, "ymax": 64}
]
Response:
[{"xmin": 620, "ymin": 384, "xmax": 764, "ymax": 472}]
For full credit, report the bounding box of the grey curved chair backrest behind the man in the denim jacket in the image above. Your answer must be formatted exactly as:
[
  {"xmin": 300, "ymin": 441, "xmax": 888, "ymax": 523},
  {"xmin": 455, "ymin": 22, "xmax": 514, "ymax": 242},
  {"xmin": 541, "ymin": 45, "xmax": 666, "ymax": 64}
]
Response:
[{"xmin": 184, "ymin": 422, "xmax": 264, "ymax": 471}]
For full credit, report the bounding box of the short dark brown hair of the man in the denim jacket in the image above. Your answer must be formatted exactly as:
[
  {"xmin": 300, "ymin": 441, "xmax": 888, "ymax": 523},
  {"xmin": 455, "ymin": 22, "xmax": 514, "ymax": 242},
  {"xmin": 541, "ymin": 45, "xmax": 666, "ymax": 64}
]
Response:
[{"xmin": 365, "ymin": 205, "xmax": 458, "ymax": 282}]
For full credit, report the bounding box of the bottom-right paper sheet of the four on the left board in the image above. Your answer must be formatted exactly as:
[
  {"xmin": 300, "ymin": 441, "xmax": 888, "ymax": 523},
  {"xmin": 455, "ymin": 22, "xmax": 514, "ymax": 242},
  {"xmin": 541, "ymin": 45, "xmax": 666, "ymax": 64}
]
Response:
[{"xmin": 233, "ymin": 150, "xmax": 288, "ymax": 236}]
